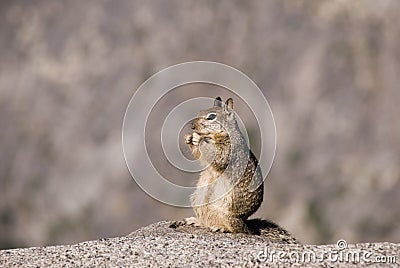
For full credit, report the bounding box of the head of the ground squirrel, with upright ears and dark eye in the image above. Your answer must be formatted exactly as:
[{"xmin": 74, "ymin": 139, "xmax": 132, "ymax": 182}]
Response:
[{"xmin": 192, "ymin": 97, "xmax": 237, "ymax": 135}]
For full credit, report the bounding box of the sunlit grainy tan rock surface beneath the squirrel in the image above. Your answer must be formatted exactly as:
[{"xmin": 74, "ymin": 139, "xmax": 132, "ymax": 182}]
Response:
[{"xmin": 0, "ymin": 220, "xmax": 400, "ymax": 267}]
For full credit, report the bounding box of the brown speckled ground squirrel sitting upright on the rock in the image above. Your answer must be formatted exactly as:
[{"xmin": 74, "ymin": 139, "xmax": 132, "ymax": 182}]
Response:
[{"xmin": 174, "ymin": 97, "xmax": 264, "ymax": 233}]
